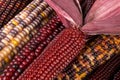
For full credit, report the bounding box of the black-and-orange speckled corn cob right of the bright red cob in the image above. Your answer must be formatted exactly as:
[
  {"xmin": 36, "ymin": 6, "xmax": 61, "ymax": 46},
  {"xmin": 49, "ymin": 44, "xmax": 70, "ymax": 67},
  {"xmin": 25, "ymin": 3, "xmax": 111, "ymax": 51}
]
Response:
[{"xmin": 58, "ymin": 35, "xmax": 120, "ymax": 80}]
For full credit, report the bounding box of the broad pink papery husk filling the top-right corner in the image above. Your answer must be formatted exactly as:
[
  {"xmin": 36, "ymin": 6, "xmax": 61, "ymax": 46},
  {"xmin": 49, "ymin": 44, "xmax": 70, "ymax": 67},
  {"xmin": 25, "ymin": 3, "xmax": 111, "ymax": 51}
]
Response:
[{"xmin": 82, "ymin": 0, "xmax": 120, "ymax": 35}]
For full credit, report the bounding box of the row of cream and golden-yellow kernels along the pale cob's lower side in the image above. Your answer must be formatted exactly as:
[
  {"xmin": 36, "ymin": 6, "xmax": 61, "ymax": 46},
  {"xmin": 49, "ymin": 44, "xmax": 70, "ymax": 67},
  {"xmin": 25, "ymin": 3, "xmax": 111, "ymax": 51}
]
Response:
[{"xmin": 0, "ymin": 8, "xmax": 54, "ymax": 70}]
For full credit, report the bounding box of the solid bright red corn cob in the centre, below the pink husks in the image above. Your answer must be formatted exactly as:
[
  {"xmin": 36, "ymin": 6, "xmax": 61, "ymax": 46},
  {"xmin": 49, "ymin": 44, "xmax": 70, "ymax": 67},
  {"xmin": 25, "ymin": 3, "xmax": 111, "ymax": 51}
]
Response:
[{"xmin": 18, "ymin": 28, "xmax": 85, "ymax": 80}]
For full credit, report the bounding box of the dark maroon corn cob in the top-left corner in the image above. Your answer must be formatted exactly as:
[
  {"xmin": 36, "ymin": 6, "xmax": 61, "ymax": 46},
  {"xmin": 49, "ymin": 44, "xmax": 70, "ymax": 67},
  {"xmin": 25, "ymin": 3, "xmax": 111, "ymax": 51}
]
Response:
[{"xmin": 0, "ymin": 0, "xmax": 32, "ymax": 28}]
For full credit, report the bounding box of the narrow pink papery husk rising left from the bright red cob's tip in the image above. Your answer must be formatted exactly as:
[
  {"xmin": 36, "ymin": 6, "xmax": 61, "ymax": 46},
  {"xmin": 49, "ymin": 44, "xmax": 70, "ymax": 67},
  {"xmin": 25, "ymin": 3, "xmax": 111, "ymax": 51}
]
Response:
[{"xmin": 45, "ymin": 0, "xmax": 83, "ymax": 27}]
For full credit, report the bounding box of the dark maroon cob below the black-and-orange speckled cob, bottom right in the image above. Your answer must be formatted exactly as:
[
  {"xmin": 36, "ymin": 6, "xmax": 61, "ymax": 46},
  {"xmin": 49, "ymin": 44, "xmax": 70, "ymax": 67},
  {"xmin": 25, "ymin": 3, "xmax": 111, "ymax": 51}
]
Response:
[{"xmin": 87, "ymin": 54, "xmax": 120, "ymax": 80}]
